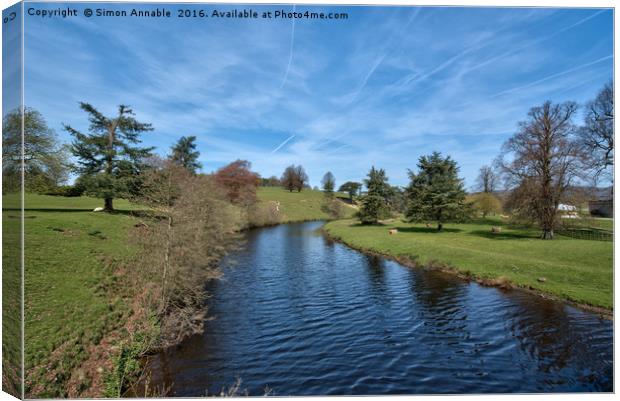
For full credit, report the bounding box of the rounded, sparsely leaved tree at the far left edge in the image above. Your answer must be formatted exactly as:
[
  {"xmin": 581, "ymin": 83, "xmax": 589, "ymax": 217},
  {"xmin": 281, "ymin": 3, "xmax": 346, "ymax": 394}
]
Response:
[{"xmin": 2, "ymin": 107, "xmax": 69, "ymax": 192}]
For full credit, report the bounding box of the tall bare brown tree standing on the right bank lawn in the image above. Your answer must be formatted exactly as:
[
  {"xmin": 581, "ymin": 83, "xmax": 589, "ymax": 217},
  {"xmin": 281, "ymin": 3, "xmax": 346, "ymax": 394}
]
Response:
[{"xmin": 500, "ymin": 101, "xmax": 583, "ymax": 239}]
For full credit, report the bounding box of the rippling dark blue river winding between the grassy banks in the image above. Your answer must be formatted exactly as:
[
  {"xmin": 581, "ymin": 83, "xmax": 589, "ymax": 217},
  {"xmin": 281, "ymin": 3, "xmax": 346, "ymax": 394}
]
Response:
[{"xmin": 150, "ymin": 222, "xmax": 613, "ymax": 396}]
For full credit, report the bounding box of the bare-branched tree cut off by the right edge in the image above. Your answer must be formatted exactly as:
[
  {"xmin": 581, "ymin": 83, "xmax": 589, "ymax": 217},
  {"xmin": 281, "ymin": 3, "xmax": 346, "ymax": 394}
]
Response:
[{"xmin": 578, "ymin": 82, "xmax": 614, "ymax": 179}]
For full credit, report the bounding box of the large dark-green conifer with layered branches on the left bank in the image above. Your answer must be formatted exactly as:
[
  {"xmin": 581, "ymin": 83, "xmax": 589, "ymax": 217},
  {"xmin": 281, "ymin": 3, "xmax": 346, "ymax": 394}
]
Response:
[{"xmin": 64, "ymin": 102, "xmax": 153, "ymax": 211}]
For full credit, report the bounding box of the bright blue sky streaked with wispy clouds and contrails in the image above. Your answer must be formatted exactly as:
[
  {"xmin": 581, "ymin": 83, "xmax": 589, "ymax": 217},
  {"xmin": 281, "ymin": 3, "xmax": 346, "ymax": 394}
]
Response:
[{"xmin": 20, "ymin": 3, "xmax": 613, "ymax": 187}]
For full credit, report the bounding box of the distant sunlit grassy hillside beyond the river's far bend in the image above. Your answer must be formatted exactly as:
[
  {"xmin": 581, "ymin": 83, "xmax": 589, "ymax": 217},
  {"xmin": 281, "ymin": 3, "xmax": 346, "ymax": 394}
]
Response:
[{"xmin": 258, "ymin": 187, "xmax": 355, "ymax": 223}]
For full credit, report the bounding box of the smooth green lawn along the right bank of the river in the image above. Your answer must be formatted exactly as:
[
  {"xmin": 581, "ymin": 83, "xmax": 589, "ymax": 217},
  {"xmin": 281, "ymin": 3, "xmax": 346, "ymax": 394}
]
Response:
[{"xmin": 325, "ymin": 219, "xmax": 613, "ymax": 309}]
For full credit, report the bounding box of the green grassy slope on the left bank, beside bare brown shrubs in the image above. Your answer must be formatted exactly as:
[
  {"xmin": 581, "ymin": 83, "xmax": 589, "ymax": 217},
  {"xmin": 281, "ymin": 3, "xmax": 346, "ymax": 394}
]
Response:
[{"xmin": 3, "ymin": 194, "xmax": 142, "ymax": 397}]
